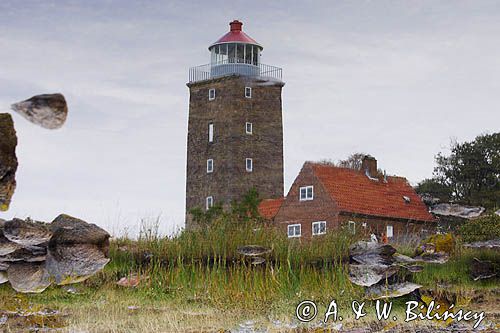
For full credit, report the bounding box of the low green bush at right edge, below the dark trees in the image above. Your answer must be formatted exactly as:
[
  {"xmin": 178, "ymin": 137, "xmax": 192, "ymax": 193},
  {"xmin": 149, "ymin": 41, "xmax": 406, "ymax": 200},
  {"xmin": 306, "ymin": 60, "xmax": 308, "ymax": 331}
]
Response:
[{"xmin": 459, "ymin": 214, "xmax": 500, "ymax": 243}]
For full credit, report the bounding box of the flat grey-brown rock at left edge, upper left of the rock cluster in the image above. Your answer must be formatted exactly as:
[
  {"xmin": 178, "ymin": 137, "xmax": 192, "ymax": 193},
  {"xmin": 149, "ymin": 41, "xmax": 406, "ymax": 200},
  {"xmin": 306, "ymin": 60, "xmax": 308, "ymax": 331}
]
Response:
[{"xmin": 3, "ymin": 218, "xmax": 52, "ymax": 248}]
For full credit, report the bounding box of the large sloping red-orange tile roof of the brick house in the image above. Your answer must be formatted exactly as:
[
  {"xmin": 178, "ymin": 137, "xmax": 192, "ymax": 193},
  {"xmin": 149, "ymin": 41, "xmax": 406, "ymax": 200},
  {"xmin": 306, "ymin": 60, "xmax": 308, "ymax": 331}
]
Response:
[{"xmin": 312, "ymin": 163, "xmax": 435, "ymax": 221}]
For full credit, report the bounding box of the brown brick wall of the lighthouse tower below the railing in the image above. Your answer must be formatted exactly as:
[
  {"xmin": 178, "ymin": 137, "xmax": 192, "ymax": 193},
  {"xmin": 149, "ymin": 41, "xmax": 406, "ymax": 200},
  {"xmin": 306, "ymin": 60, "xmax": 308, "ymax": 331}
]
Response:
[{"xmin": 186, "ymin": 76, "xmax": 283, "ymax": 228}]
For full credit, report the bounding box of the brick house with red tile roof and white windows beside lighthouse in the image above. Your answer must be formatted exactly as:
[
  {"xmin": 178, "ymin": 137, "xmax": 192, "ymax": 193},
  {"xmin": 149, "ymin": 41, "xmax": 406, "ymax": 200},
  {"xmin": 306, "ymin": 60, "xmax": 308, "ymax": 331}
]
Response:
[{"xmin": 259, "ymin": 156, "xmax": 436, "ymax": 239}]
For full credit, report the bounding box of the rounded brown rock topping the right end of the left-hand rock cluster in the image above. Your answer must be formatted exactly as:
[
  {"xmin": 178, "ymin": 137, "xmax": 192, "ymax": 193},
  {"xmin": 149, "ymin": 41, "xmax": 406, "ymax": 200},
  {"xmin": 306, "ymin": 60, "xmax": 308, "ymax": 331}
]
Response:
[{"xmin": 49, "ymin": 214, "xmax": 110, "ymax": 248}]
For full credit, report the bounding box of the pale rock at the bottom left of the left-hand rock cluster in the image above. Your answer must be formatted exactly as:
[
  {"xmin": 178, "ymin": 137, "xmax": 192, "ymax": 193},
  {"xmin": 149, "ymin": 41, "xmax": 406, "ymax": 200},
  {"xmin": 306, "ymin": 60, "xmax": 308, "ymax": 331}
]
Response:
[{"xmin": 7, "ymin": 262, "xmax": 50, "ymax": 293}]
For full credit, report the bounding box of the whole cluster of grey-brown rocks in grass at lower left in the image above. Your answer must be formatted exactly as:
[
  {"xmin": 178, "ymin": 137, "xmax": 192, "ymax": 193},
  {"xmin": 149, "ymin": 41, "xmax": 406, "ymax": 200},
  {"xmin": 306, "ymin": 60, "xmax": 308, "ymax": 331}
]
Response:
[{"xmin": 0, "ymin": 214, "xmax": 110, "ymax": 293}]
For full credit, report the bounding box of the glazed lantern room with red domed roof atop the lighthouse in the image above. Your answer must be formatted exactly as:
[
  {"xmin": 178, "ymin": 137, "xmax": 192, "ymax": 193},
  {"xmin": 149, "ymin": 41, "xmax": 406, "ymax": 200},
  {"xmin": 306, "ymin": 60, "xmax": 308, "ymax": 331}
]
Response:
[{"xmin": 208, "ymin": 20, "xmax": 263, "ymax": 66}]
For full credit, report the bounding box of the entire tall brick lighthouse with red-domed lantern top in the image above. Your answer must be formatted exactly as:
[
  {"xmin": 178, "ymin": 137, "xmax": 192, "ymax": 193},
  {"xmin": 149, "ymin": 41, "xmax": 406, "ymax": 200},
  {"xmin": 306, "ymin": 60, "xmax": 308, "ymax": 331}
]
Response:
[{"xmin": 186, "ymin": 20, "xmax": 284, "ymax": 229}]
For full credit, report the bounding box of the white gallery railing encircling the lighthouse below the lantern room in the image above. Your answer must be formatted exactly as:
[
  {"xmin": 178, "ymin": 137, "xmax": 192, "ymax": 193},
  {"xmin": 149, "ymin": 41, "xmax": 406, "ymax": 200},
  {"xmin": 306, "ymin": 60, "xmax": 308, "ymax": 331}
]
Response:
[{"xmin": 189, "ymin": 59, "xmax": 283, "ymax": 83}]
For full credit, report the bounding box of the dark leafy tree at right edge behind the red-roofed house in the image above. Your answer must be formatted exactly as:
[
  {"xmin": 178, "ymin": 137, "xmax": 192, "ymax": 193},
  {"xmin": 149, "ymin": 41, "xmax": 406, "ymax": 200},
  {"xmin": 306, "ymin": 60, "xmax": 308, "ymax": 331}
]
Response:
[{"xmin": 433, "ymin": 133, "xmax": 500, "ymax": 208}]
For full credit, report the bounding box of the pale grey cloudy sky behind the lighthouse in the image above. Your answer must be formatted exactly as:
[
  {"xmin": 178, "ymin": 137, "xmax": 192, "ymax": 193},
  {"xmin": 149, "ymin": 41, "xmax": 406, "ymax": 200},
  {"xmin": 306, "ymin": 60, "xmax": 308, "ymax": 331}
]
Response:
[{"xmin": 0, "ymin": 0, "xmax": 500, "ymax": 236}]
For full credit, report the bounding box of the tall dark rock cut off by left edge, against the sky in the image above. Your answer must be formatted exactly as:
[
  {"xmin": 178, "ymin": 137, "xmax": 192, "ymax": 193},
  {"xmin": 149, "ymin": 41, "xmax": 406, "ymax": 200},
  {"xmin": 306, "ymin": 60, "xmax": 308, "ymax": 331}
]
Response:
[{"xmin": 0, "ymin": 113, "xmax": 17, "ymax": 211}]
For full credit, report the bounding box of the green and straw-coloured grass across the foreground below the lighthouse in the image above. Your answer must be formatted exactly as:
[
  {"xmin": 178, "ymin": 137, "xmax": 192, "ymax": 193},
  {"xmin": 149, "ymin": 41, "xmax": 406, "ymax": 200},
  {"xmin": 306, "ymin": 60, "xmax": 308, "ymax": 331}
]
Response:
[{"xmin": 0, "ymin": 215, "xmax": 498, "ymax": 332}]
